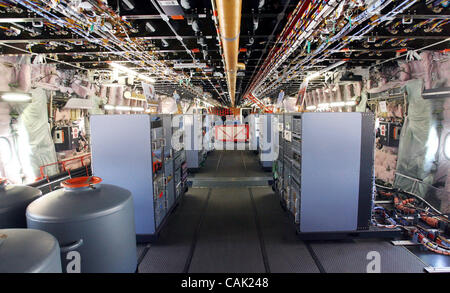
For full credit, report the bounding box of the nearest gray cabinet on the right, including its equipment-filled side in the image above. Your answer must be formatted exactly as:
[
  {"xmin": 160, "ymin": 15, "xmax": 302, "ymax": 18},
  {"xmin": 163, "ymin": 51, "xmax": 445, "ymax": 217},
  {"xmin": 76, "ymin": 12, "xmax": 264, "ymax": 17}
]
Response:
[{"xmin": 278, "ymin": 112, "xmax": 375, "ymax": 233}]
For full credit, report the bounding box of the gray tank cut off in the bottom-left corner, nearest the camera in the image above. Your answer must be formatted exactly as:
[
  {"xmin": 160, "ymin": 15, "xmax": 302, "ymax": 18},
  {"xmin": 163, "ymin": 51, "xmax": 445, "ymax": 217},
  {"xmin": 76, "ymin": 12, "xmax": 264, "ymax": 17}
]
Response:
[{"xmin": 0, "ymin": 229, "xmax": 62, "ymax": 273}]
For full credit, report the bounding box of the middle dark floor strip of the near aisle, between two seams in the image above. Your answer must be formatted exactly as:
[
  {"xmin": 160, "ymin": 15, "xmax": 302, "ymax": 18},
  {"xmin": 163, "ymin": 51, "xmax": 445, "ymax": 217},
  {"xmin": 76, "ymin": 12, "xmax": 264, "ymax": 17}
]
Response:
[{"xmin": 189, "ymin": 188, "xmax": 265, "ymax": 273}]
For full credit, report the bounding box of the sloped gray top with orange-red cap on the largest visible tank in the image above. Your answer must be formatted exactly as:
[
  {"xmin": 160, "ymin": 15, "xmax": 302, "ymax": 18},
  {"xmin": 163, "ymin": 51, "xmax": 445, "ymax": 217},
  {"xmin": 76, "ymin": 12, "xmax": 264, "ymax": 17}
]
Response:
[{"xmin": 26, "ymin": 177, "xmax": 131, "ymax": 223}]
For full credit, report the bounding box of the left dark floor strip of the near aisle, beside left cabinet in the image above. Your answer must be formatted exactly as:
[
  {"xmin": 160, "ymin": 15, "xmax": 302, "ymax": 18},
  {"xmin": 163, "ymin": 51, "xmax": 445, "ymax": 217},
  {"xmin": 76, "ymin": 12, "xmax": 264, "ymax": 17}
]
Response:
[{"xmin": 139, "ymin": 188, "xmax": 208, "ymax": 273}]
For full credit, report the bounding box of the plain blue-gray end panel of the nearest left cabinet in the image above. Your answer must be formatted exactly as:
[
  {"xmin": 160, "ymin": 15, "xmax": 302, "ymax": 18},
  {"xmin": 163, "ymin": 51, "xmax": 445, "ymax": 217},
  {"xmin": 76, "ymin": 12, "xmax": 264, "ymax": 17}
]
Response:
[{"xmin": 91, "ymin": 115, "xmax": 156, "ymax": 234}]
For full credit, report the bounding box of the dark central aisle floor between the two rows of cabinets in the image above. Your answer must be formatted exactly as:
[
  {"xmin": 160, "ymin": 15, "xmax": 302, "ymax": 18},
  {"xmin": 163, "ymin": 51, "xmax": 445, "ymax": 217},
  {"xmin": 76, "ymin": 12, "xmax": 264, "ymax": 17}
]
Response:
[{"xmin": 139, "ymin": 151, "xmax": 319, "ymax": 273}]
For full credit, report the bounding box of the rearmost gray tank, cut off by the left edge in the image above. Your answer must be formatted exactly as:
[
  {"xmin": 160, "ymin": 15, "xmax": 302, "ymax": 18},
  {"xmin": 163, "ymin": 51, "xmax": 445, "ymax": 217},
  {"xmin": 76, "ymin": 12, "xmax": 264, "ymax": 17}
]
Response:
[{"xmin": 0, "ymin": 178, "xmax": 42, "ymax": 229}]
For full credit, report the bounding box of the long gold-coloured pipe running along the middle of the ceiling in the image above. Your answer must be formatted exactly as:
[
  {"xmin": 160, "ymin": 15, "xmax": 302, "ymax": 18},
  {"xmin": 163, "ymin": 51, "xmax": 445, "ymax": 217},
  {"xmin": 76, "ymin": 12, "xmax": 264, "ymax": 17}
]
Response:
[{"xmin": 216, "ymin": 0, "xmax": 242, "ymax": 107}]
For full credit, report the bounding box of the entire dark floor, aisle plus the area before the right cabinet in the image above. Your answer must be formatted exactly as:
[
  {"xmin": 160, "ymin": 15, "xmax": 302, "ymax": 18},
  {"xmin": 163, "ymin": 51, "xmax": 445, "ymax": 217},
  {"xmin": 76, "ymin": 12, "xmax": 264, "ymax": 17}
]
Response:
[{"xmin": 139, "ymin": 151, "xmax": 427, "ymax": 273}]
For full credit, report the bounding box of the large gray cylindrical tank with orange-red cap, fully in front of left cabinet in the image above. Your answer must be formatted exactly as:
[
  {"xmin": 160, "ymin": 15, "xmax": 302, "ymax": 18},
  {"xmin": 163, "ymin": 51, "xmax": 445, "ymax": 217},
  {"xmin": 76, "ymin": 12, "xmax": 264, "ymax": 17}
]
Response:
[{"xmin": 26, "ymin": 176, "xmax": 137, "ymax": 273}]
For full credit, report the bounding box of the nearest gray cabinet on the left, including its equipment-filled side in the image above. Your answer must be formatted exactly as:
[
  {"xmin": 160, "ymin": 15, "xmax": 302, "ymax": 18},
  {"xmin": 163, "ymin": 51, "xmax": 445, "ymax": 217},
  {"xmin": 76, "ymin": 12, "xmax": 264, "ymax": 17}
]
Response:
[{"xmin": 91, "ymin": 114, "xmax": 174, "ymax": 241}]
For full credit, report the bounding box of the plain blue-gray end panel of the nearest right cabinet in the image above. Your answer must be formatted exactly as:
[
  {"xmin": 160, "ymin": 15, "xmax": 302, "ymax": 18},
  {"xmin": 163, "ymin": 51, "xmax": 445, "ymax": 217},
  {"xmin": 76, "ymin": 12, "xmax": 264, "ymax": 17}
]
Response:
[{"xmin": 300, "ymin": 113, "xmax": 373, "ymax": 232}]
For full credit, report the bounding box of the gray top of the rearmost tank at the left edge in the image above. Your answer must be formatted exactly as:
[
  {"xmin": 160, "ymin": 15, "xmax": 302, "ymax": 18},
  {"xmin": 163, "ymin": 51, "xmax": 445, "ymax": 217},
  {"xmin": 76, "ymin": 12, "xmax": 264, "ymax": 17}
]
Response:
[{"xmin": 0, "ymin": 185, "xmax": 42, "ymax": 210}]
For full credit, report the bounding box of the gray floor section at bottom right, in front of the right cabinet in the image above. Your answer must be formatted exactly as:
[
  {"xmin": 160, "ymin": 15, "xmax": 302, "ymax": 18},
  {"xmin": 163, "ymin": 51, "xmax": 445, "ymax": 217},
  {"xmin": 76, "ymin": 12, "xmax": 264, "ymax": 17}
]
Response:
[{"xmin": 311, "ymin": 239, "xmax": 426, "ymax": 273}]
